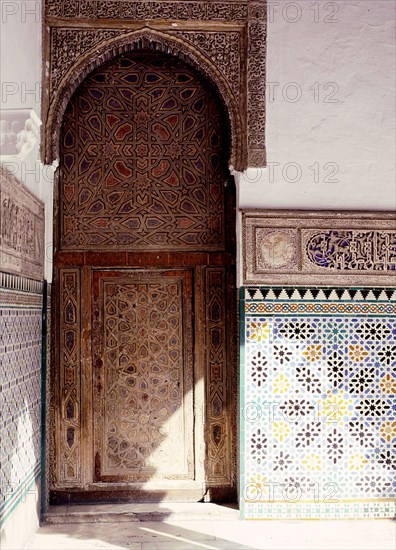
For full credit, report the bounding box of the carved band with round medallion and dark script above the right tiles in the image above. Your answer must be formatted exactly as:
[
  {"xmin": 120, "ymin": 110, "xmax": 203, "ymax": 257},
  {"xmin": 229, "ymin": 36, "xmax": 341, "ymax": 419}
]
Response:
[{"xmin": 242, "ymin": 211, "xmax": 396, "ymax": 286}]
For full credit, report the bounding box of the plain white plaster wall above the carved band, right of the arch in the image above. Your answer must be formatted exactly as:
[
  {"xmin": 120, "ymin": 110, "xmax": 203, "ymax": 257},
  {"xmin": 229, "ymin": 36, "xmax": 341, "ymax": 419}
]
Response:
[{"xmin": 238, "ymin": 0, "xmax": 396, "ymax": 210}]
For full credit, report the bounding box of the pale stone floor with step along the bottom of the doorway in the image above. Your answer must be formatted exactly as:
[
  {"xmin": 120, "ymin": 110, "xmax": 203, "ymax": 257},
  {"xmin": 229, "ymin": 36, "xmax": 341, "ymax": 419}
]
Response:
[{"xmin": 28, "ymin": 504, "xmax": 396, "ymax": 550}]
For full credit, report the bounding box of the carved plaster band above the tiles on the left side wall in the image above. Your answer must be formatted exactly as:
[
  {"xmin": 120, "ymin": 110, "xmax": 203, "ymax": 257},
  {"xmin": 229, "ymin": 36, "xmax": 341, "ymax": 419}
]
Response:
[{"xmin": 0, "ymin": 164, "xmax": 44, "ymax": 280}]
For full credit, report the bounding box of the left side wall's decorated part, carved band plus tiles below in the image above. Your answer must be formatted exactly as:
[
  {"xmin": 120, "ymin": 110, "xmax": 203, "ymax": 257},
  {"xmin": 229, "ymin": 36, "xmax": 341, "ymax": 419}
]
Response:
[{"xmin": 0, "ymin": 163, "xmax": 45, "ymax": 548}]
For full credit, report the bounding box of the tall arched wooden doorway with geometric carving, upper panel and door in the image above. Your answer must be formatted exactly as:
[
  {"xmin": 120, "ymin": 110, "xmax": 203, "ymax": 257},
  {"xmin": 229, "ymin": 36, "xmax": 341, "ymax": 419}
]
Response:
[{"xmin": 51, "ymin": 50, "xmax": 237, "ymax": 503}]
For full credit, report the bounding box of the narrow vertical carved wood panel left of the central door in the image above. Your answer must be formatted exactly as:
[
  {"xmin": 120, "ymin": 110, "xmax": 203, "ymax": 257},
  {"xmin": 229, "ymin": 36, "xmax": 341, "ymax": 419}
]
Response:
[{"xmin": 54, "ymin": 269, "xmax": 81, "ymax": 486}]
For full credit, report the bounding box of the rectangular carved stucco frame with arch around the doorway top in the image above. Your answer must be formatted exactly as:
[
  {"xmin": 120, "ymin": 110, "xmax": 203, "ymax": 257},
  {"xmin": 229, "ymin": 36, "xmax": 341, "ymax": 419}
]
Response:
[{"xmin": 43, "ymin": 0, "xmax": 266, "ymax": 170}]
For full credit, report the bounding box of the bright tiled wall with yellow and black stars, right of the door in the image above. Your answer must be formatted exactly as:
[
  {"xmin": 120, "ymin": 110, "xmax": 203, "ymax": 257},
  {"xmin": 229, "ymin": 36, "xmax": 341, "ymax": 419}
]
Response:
[{"xmin": 241, "ymin": 287, "xmax": 396, "ymax": 519}]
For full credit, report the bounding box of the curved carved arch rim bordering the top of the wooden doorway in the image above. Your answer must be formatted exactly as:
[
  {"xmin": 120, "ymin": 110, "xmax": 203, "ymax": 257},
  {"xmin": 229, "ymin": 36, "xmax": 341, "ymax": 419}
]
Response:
[{"xmin": 44, "ymin": 27, "xmax": 246, "ymax": 171}]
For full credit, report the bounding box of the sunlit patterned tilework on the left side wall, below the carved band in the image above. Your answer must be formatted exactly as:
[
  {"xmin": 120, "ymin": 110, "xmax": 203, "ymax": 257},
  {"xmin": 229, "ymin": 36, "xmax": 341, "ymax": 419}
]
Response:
[{"xmin": 0, "ymin": 280, "xmax": 43, "ymax": 524}]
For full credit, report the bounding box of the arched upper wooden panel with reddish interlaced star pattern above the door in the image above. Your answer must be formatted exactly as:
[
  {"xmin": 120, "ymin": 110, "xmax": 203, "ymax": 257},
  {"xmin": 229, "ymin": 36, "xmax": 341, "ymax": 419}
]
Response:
[{"xmin": 61, "ymin": 52, "xmax": 226, "ymax": 250}]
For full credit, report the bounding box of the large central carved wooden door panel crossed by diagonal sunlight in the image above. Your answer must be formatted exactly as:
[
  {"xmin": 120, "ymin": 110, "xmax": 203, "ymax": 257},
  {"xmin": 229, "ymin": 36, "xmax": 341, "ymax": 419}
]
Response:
[{"xmin": 93, "ymin": 270, "xmax": 194, "ymax": 481}]
